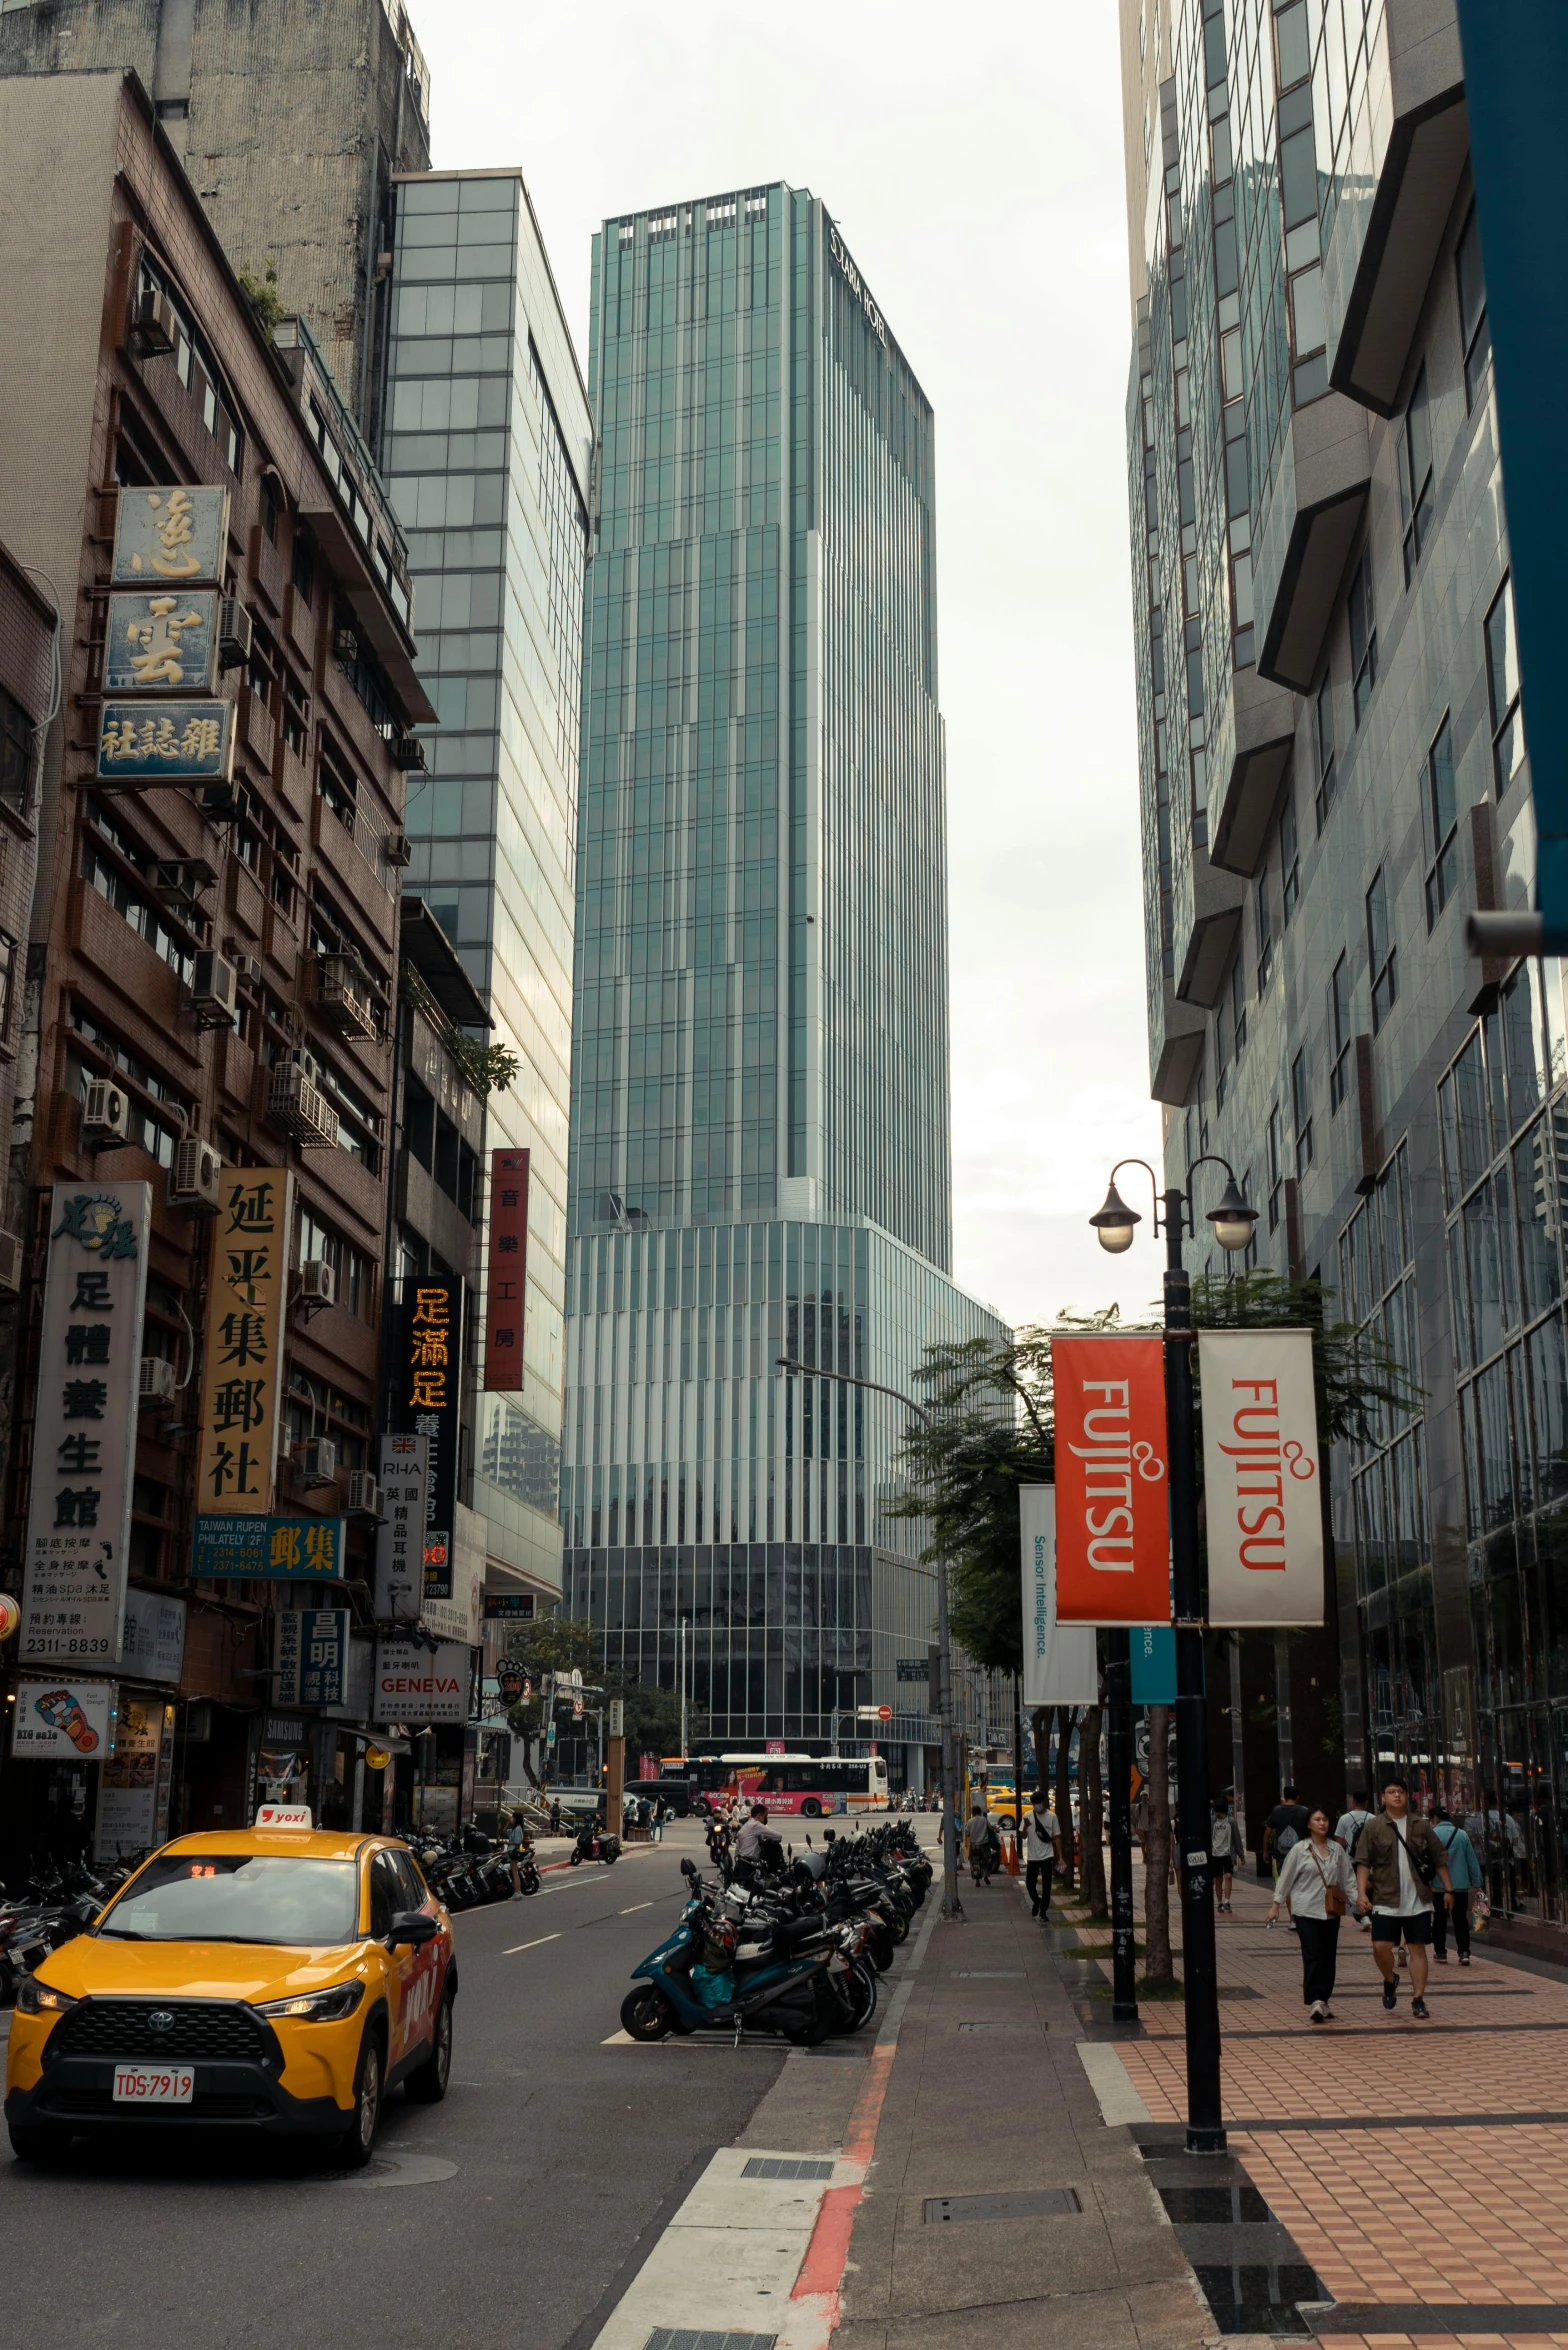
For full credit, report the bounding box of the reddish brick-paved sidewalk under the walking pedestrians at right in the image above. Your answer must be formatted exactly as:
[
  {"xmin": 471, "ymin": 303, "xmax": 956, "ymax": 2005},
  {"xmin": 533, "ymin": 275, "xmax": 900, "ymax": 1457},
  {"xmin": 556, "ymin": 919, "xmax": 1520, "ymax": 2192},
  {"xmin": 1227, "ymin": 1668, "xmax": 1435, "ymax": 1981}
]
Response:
[{"xmin": 1095, "ymin": 1842, "xmax": 1568, "ymax": 2350}]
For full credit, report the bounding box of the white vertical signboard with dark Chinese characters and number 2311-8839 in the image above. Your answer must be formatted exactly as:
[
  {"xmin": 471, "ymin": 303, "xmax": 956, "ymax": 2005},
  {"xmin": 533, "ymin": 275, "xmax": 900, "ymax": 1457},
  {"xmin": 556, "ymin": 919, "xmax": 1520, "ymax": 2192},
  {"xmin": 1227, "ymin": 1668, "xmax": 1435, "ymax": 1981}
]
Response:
[{"xmin": 21, "ymin": 1182, "xmax": 153, "ymax": 1669}]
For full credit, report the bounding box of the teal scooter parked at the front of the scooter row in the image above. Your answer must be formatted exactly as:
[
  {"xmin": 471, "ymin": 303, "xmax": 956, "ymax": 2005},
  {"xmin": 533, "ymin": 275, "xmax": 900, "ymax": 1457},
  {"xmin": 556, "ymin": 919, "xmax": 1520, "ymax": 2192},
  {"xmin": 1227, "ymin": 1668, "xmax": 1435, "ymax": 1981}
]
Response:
[{"xmin": 621, "ymin": 1861, "xmax": 835, "ymax": 2047}]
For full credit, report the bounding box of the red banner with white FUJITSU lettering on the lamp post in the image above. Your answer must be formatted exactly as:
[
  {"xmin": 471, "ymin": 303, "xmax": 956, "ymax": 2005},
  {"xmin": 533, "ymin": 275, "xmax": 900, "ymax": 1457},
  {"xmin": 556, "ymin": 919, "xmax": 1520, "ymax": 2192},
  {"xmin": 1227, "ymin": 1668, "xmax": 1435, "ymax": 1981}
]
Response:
[{"xmin": 1051, "ymin": 1337, "xmax": 1171, "ymax": 1624}]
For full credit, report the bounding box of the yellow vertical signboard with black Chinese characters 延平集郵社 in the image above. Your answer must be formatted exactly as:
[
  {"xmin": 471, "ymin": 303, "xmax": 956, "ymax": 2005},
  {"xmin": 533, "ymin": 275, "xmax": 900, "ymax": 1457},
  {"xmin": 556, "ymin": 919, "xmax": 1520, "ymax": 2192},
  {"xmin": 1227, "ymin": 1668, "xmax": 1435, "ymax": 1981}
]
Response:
[{"xmin": 195, "ymin": 1168, "xmax": 294, "ymax": 1522}]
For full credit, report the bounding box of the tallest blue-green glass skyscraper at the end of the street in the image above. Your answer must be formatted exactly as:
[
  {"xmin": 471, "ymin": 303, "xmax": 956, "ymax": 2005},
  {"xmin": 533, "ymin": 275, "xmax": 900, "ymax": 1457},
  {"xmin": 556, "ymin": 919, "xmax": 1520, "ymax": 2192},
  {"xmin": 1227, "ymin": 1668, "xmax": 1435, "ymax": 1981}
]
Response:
[{"xmin": 564, "ymin": 183, "xmax": 1001, "ymax": 1770}]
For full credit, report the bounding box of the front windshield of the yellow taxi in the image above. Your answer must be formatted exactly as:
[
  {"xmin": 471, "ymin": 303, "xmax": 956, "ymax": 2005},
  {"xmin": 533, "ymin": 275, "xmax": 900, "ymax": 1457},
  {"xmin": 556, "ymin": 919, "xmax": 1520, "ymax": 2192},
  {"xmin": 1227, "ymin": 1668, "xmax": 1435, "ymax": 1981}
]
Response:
[{"xmin": 99, "ymin": 1852, "xmax": 360, "ymax": 1943}]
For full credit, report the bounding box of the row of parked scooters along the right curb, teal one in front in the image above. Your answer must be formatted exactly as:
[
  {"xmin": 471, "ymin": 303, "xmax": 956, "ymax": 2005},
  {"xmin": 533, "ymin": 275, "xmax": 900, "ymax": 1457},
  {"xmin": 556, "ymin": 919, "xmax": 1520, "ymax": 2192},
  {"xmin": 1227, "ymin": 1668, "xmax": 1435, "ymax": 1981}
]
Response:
[{"xmin": 621, "ymin": 1821, "xmax": 931, "ymax": 2047}]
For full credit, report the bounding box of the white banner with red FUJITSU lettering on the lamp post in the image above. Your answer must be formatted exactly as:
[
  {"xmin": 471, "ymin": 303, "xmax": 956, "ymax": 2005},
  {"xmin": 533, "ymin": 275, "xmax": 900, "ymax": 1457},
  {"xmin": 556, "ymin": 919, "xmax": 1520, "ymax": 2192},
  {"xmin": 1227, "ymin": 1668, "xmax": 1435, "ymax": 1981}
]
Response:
[{"xmin": 1199, "ymin": 1330, "xmax": 1324, "ymax": 1626}]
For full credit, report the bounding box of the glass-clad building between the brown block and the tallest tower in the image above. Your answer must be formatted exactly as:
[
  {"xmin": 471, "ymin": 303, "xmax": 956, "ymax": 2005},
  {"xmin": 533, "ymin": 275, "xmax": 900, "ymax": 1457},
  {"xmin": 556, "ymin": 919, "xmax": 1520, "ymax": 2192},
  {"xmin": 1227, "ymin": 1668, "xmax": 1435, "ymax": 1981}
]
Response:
[{"xmin": 381, "ymin": 172, "xmax": 592, "ymax": 1591}]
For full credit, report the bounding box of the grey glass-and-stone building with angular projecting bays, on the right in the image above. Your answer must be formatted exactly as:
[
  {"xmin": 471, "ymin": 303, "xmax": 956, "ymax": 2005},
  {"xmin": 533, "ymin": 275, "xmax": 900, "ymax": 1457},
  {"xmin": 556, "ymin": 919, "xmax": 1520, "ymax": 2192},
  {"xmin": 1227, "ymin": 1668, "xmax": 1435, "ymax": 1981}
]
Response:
[{"xmin": 1121, "ymin": 0, "xmax": 1568, "ymax": 1925}]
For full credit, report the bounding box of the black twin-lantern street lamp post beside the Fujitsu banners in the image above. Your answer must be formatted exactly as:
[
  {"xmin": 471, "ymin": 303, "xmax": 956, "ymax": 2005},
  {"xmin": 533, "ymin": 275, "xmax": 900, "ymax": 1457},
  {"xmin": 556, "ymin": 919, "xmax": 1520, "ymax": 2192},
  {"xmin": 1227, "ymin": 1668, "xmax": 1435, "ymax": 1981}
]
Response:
[{"xmin": 1088, "ymin": 1152, "xmax": 1258, "ymax": 2155}]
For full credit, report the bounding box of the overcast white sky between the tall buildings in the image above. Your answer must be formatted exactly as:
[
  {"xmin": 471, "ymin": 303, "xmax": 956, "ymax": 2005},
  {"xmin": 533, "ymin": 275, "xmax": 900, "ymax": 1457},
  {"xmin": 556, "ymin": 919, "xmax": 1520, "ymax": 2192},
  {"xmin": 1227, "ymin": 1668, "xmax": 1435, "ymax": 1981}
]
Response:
[{"xmin": 414, "ymin": 0, "xmax": 1159, "ymax": 1323}]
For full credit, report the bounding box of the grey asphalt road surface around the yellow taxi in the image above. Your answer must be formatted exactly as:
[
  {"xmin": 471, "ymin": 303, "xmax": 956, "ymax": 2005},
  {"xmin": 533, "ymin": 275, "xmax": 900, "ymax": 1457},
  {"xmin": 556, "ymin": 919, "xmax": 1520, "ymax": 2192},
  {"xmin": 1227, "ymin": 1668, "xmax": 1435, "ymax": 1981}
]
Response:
[{"xmin": 0, "ymin": 1824, "xmax": 783, "ymax": 2350}]
